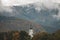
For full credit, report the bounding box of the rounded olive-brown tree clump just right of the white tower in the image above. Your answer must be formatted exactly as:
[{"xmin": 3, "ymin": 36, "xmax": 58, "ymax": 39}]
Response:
[{"xmin": 32, "ymin": 32, "xmax": 51, "ymax": 40}]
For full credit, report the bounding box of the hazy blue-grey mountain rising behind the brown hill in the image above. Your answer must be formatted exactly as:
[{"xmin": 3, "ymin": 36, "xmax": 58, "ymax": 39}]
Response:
[{"xmin": 0, "ymin": 3, "xmax": 60, "ymax": 32}]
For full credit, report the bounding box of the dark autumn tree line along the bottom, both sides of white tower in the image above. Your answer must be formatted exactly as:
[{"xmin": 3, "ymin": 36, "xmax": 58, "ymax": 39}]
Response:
[{"xmin": 0, "ymin": 30, "xmax": 60, "ymax": 40}]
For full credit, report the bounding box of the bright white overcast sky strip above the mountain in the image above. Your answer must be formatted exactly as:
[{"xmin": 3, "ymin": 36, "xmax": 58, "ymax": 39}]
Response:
[{"xmin": 1, "ymin": 0, "xmax": 60, "ymax": 6}]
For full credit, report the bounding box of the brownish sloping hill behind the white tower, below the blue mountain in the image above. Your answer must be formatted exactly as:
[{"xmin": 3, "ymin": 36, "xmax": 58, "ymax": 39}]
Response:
[{"xmin": 0, "ymin": 16, "xmax": 45, "ymax": 32}]
